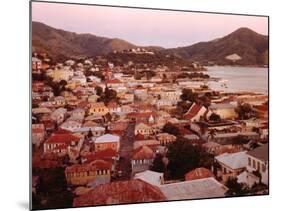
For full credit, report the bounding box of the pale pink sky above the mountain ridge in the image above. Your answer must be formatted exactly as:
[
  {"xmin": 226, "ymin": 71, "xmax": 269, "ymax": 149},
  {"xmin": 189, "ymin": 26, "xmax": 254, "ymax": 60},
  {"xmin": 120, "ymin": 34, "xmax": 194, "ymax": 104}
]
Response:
[{"xmin": 32, "ymin": 2, "xmax": 268, "ymax": 48}]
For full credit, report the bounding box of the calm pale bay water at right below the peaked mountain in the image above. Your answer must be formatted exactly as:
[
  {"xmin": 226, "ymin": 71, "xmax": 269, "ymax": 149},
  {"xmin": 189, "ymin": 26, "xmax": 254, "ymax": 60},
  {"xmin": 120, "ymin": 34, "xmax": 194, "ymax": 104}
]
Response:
[{"xmin": 207, "ymin": 66, "xmax": 269, "ymax": 94}]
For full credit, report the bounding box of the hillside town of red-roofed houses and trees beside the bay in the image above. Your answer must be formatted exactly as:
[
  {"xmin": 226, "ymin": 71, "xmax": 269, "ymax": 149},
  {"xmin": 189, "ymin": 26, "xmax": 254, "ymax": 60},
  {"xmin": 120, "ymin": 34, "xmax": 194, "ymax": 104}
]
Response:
[{"xmin": 31, "ymin": 48, "xmax": 269, "ymax": 209}]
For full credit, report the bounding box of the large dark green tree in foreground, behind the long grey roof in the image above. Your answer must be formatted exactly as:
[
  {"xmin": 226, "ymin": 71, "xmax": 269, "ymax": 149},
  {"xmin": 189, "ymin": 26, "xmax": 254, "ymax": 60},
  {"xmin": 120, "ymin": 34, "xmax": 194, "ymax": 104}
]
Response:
[{"xmin": 167, "ymin": 140, "xmax": 206, "ymax": 179}]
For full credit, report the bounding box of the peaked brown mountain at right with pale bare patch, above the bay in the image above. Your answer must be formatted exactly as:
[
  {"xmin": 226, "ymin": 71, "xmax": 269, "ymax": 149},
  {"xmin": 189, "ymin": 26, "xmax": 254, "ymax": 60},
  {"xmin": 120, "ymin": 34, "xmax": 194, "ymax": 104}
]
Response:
[{"xmin": 164, "ymin": 27, "xmax": 268, "ymax": 65}]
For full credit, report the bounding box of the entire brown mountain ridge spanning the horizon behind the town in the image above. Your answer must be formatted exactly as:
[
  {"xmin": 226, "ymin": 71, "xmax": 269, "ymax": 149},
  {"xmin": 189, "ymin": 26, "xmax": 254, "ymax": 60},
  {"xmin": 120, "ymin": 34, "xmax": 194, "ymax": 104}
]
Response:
[{"xmin": 32, "ymin": 21, "xmax": 268, "ymax": 65}]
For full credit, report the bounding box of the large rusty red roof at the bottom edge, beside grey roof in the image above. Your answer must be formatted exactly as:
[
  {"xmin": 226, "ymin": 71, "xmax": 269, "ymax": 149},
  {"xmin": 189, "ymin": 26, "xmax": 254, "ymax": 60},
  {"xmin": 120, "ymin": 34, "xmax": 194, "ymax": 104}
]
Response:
[{"xmin": 73, "ymin": 180, "xmax": 167, "ymax": 207}]
